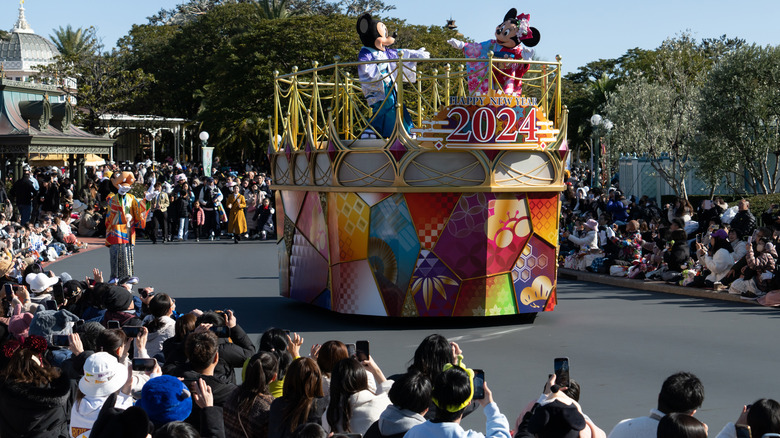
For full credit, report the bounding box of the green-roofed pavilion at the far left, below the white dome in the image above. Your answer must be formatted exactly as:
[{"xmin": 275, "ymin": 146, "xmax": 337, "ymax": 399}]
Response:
[{"xmin": 0, "ymin": 78, "xmax": 114, "ymax": 188}]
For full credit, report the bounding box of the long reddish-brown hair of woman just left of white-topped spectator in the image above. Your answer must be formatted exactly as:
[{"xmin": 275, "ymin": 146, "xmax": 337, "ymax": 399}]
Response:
[{"xmin": 282, "ymin": 357, "xmax": 322, "ymax": 433}]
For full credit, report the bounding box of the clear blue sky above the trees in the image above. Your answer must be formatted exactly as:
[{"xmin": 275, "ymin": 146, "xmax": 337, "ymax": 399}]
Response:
[{"xmin": 6, "ymin": 0, "xmax": 780, "ymax": 75}]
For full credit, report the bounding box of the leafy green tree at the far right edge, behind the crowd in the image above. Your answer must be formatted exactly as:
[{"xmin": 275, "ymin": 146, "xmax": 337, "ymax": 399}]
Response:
[{"xmin": 697, "ymin": 44, "xmax": 780, "ymax": 194}]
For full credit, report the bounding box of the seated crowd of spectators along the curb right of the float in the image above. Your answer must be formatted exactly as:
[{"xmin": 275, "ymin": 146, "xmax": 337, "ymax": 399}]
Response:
[{"xmin": 559, "ymin": 168, "xmax": 780, "ymax": 306}]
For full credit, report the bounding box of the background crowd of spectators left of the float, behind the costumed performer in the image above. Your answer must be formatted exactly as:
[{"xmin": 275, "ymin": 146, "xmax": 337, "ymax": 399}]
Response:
[{"xmin": 0, "ymin": 160, "xmax": 276, "ymax": 271}]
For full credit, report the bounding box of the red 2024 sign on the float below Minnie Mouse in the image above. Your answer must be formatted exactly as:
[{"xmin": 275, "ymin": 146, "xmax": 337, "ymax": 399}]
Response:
[{"xmin": 446, "ymin": 106, "xmax": 539, "ymax": 145}]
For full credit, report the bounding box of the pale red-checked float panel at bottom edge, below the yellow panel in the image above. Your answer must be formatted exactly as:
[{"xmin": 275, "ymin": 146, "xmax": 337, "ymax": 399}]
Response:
[{"xmin": 331, "ymin": 260, "xmax": 387, "ymax": 316}]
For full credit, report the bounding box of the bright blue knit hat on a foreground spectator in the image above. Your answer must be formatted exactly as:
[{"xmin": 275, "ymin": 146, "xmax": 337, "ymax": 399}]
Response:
[{"xmin": 135, "ymin": 375, "xmax": 192, "ymax": 425}]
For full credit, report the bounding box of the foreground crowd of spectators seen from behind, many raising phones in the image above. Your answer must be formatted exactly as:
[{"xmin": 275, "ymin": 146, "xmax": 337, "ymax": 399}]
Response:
[{"xmin": 0, "ymin": 265, "xmax": 780, "ymax": 438}]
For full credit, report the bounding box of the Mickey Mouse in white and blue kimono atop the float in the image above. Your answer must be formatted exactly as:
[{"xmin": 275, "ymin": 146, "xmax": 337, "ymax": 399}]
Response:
[{"xmin": 356, "ymin": 13, "xmax": 430, "ymax": 138}]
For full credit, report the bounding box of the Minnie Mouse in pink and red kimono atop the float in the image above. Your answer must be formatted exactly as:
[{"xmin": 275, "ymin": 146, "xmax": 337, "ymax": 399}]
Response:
[{"xmin": 447, "ymin": 8, "xmax": 540, "ymax": 95}]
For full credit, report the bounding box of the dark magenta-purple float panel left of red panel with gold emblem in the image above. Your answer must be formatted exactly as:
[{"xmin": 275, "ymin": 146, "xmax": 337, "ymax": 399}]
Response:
[{"xmin": 433, "ymin": 193, "xmax": 496, "ymax": 279}]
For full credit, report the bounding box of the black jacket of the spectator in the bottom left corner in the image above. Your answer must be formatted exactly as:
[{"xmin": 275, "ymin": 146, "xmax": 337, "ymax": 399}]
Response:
[{"xmin": 0, "ymin": 374, "xmax": 75, "ymax": 438}]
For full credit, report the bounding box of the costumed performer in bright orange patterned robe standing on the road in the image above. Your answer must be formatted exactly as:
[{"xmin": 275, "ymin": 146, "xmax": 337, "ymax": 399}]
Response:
[{"xmin": 106, "ymin": 171, "xmax": 147, "ymax": 279}]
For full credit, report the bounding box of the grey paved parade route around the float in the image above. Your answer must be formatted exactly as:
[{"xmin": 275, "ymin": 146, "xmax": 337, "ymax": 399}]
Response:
[{"xmin": 51, "ymin": 240, "xmax": 780, "ymax": 436}]
